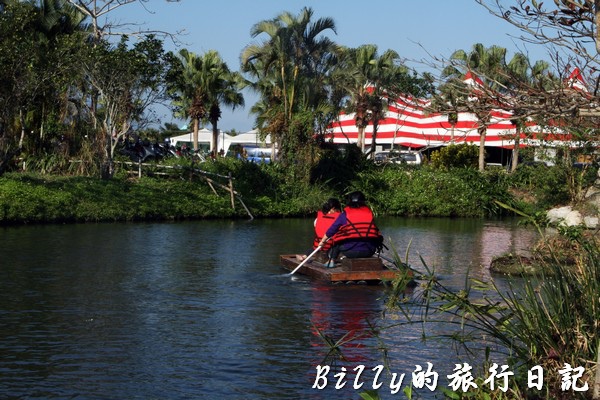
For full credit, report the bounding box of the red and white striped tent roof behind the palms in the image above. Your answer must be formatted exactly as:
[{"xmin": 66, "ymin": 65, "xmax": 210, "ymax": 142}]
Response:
[{"xmin": 329, "ymin": 70, "xmax": 585, "ymax": 148}]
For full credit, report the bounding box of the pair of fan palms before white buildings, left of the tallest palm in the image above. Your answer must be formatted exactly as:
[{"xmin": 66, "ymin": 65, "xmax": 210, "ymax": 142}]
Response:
[{"xmin": 171, "ymin": 49, "xmax": 244, "ymax": 154}]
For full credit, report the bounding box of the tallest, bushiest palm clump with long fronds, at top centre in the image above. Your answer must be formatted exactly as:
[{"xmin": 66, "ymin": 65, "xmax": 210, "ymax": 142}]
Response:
[{"xmin": 241, "ymin": 8, "xmax": 337, "ymax": 162}]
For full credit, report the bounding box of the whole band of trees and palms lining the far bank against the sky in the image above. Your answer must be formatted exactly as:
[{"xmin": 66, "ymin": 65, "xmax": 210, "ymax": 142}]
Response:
[{"xmin": 0, "ymin": 0, "xmax": 600, "ymax": 180}]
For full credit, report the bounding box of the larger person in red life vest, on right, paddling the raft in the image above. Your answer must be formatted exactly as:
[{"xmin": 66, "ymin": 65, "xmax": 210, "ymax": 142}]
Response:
[{"xmin": 319, "ymin": 191, "xmax": 383, "ymax": 268}]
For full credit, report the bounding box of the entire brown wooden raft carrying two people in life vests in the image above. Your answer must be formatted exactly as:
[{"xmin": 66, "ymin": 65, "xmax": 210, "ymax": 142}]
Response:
[{"xmin": 281, "ymin": 254, "xmax": 410, "ymax": 283}]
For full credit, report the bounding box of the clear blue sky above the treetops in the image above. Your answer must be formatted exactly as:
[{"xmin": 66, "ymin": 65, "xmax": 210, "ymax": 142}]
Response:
[{"xmin": 110, "ymin": 0, "xmax": 548, "ymax": 132}]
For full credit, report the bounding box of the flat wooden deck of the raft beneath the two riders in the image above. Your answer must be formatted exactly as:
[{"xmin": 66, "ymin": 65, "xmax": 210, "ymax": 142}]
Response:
[{"xmin": 281, "ymin": 255, "xmax": 397, "ymax": 282}]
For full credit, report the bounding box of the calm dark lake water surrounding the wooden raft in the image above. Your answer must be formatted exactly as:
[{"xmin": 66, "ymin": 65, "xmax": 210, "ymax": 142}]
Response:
[{"xmin": 0, "ymin": 218, "xmax": 537, "ymax": 399}]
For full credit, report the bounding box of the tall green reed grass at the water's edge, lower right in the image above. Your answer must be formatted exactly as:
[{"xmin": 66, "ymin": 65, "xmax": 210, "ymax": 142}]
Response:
[{"xmin": 387, "ymin": 211, "xmax": 600, "ymax": 400}]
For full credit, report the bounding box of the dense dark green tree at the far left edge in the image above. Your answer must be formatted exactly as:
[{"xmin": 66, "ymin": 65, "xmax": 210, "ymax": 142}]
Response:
[{"xmin": 0, "ymin": 0, "xmax": 85, "ymax": 171}]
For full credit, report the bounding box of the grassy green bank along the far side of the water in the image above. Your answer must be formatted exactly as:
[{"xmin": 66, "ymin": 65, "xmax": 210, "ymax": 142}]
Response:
[{"xmin": 0, "ymin": 160, "xmax": 564, "ymax": 224}]
